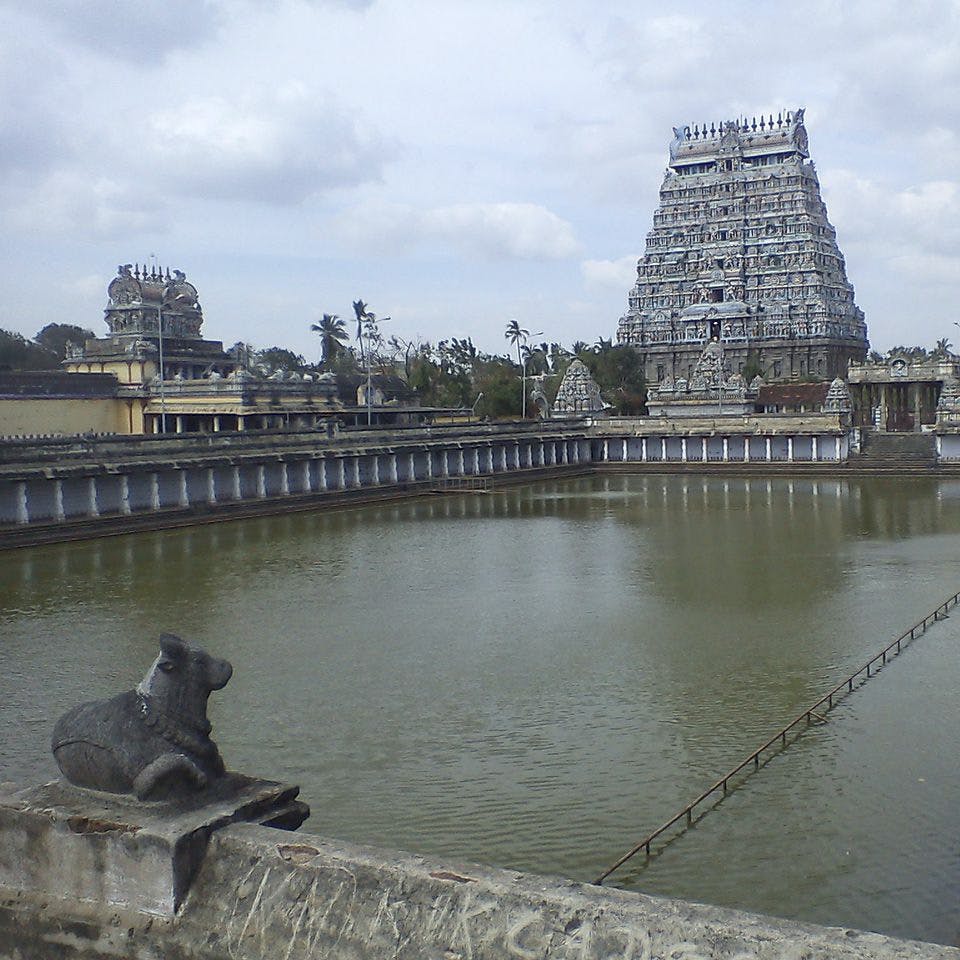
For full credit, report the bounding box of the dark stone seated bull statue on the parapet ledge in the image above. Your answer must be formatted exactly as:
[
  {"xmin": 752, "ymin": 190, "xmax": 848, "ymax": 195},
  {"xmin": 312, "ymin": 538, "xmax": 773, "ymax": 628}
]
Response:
[{"xmin": 52, "ymin": 633, "xmax": 233, "ymax": 800}]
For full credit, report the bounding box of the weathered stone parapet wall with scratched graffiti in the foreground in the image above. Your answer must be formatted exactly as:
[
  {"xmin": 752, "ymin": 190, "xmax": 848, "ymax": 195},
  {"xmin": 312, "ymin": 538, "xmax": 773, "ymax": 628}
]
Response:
[{"xmin": 0, "ymin": 810, "xmax": 960, "ymax": 960}]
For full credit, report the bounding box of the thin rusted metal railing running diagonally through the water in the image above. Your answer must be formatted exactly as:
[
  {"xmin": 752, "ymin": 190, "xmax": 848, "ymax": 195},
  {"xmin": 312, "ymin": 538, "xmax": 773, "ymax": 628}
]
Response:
[{"xmin": 593, "ymin": 592, "xmax": 960, "ymax": 884}]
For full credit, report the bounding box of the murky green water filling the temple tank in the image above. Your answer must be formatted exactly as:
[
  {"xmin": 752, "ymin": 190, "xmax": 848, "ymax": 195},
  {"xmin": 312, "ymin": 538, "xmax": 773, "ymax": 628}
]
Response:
[{"xmin": 0, "ymin": 476, "xmax": 960, "ymax": 943}]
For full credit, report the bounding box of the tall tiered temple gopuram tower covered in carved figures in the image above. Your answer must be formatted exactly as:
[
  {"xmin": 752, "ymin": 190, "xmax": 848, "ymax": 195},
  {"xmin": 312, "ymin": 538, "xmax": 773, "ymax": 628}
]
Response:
[{"xmin": 617, "ymin": 109, "xmax": 868, "ymax": 384}]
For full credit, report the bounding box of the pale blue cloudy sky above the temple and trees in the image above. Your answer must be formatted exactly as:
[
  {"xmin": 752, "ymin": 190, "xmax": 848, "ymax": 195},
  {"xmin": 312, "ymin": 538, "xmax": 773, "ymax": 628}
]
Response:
[{"xmin": 0, "ymin": 0, "xmax": 960, "ymax": 359}]
